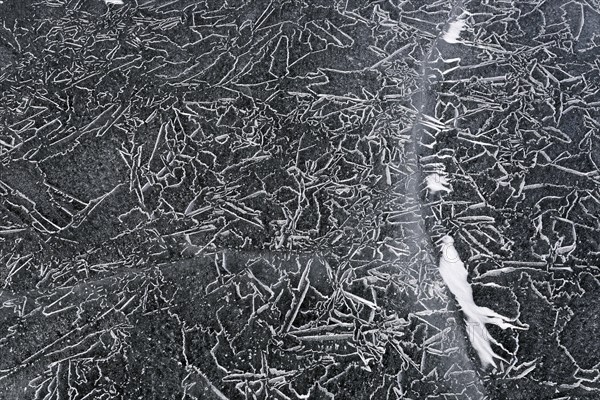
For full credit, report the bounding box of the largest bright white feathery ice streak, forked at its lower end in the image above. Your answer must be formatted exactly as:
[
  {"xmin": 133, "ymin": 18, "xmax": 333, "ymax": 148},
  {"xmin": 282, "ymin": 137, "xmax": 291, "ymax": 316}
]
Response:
[{"xmin": 439, "ymin": 236, "xmax": 524, "ymax": 367}]
